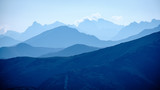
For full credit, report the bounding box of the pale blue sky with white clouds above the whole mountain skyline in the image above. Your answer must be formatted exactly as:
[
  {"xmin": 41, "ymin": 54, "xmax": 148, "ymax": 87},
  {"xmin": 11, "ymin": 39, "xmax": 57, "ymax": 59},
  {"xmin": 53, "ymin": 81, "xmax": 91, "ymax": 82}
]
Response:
[{"xmin": 0, "ymin": 0, "xmax": 160, "ymax": 32}]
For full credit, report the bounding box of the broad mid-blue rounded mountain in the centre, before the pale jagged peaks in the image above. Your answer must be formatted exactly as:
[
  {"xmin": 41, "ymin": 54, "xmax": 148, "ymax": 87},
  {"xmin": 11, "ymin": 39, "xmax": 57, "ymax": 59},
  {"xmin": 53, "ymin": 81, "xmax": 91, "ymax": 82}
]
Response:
[{"xmin": 25, "ymin": 26, "xmax": 108, "ymax": 48}]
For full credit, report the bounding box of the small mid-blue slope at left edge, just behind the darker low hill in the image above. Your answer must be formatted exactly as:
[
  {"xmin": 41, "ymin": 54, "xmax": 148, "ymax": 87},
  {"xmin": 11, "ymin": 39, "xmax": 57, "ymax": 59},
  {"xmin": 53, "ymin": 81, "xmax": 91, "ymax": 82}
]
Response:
[{"xmin": 0, "ymin": 35, "xmax": 20, "ymax": 47}]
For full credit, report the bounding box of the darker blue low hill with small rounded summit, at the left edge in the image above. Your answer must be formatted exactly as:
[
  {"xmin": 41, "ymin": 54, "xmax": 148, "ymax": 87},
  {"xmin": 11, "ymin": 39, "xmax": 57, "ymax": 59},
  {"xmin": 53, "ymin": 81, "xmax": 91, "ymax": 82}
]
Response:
[{"xmin": 0, "ymin": 43, "xmax": 61, "ymax": 59}]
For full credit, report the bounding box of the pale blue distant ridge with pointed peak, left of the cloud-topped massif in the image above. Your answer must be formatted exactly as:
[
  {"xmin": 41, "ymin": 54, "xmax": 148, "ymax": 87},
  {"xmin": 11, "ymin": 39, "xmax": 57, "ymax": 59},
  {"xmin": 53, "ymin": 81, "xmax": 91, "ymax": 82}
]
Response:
[{"xmin": 5, "ymin": 21, "xmax": 64, "ymax": 41}]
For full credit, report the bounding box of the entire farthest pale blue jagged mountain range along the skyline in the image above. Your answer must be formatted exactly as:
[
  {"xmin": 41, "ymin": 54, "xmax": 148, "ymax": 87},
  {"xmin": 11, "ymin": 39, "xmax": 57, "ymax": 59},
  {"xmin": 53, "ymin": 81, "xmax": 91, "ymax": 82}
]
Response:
[{"xmin": 4, "ymin": 18, "xmax": 160, "ymax": 41}]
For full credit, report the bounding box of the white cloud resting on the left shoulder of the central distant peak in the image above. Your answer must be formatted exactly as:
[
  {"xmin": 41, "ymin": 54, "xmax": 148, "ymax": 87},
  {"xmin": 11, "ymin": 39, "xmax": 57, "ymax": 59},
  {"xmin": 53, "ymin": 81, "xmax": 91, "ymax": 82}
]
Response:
[{"xmin": 74, "ymin": 13, "xmax": 102, "ymax": 26}]
